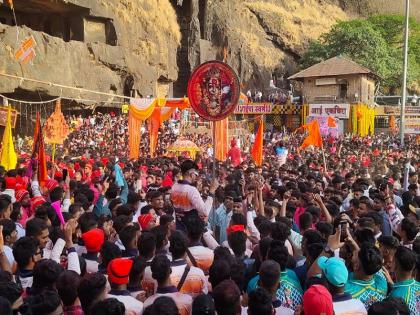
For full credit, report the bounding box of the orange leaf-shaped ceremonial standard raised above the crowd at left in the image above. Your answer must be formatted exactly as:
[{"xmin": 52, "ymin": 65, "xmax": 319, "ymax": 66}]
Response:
[{"xmin": 44, "ymin": 100, "xmax": 70, "ymax": 144}]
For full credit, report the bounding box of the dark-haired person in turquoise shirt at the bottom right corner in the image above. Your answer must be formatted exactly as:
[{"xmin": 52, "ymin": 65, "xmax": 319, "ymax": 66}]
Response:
[{"xmin": 389, "ymin": 246, "xmax": 420, "ymax": 315}]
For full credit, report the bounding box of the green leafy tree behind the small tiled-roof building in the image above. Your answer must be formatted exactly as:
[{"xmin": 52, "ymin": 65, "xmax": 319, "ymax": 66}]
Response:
[{"xmin": 300, "ymin": 15, "xmax": 420, "ymax": 94}]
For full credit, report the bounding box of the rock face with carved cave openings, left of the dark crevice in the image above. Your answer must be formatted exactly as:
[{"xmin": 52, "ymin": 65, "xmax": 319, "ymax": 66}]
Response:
[{"xmin": 0, "ymin": 0, "xmax": 181, "ymax": 99}]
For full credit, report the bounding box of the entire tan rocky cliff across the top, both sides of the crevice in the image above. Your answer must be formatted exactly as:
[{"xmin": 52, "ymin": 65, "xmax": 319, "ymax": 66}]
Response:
[{"xmin": 0, "ymin": 0, "xmax": 420, "ymax": 98}]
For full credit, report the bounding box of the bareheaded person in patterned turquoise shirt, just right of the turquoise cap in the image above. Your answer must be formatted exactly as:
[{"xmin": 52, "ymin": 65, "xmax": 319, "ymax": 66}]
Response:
[{"xmin": 344, "ymin": 242, "xmax": 388, "ymax": 309}]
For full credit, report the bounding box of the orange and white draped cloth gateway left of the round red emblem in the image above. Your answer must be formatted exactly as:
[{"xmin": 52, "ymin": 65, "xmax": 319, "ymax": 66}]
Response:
[{"xmin": 128, "ymin": 98, "xmax": 190, "ymax": 159}]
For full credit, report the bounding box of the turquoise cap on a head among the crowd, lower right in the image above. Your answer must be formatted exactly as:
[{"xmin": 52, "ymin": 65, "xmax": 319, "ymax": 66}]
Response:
[{"xmin": 318, "ymin": 256, "xmax": 349, "ymax": 287}]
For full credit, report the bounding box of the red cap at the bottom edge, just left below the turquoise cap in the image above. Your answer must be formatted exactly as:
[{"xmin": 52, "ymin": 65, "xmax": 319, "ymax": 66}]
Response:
[{"xmin": 303, "ymin": 284, "xmax": 334, "ymax": 315}]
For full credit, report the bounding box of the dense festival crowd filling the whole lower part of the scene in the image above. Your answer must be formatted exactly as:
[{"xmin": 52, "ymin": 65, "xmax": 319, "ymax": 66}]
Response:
[{"xmin": 0, "ymin": 114, "xmax": 420, "ymax": 315}]
